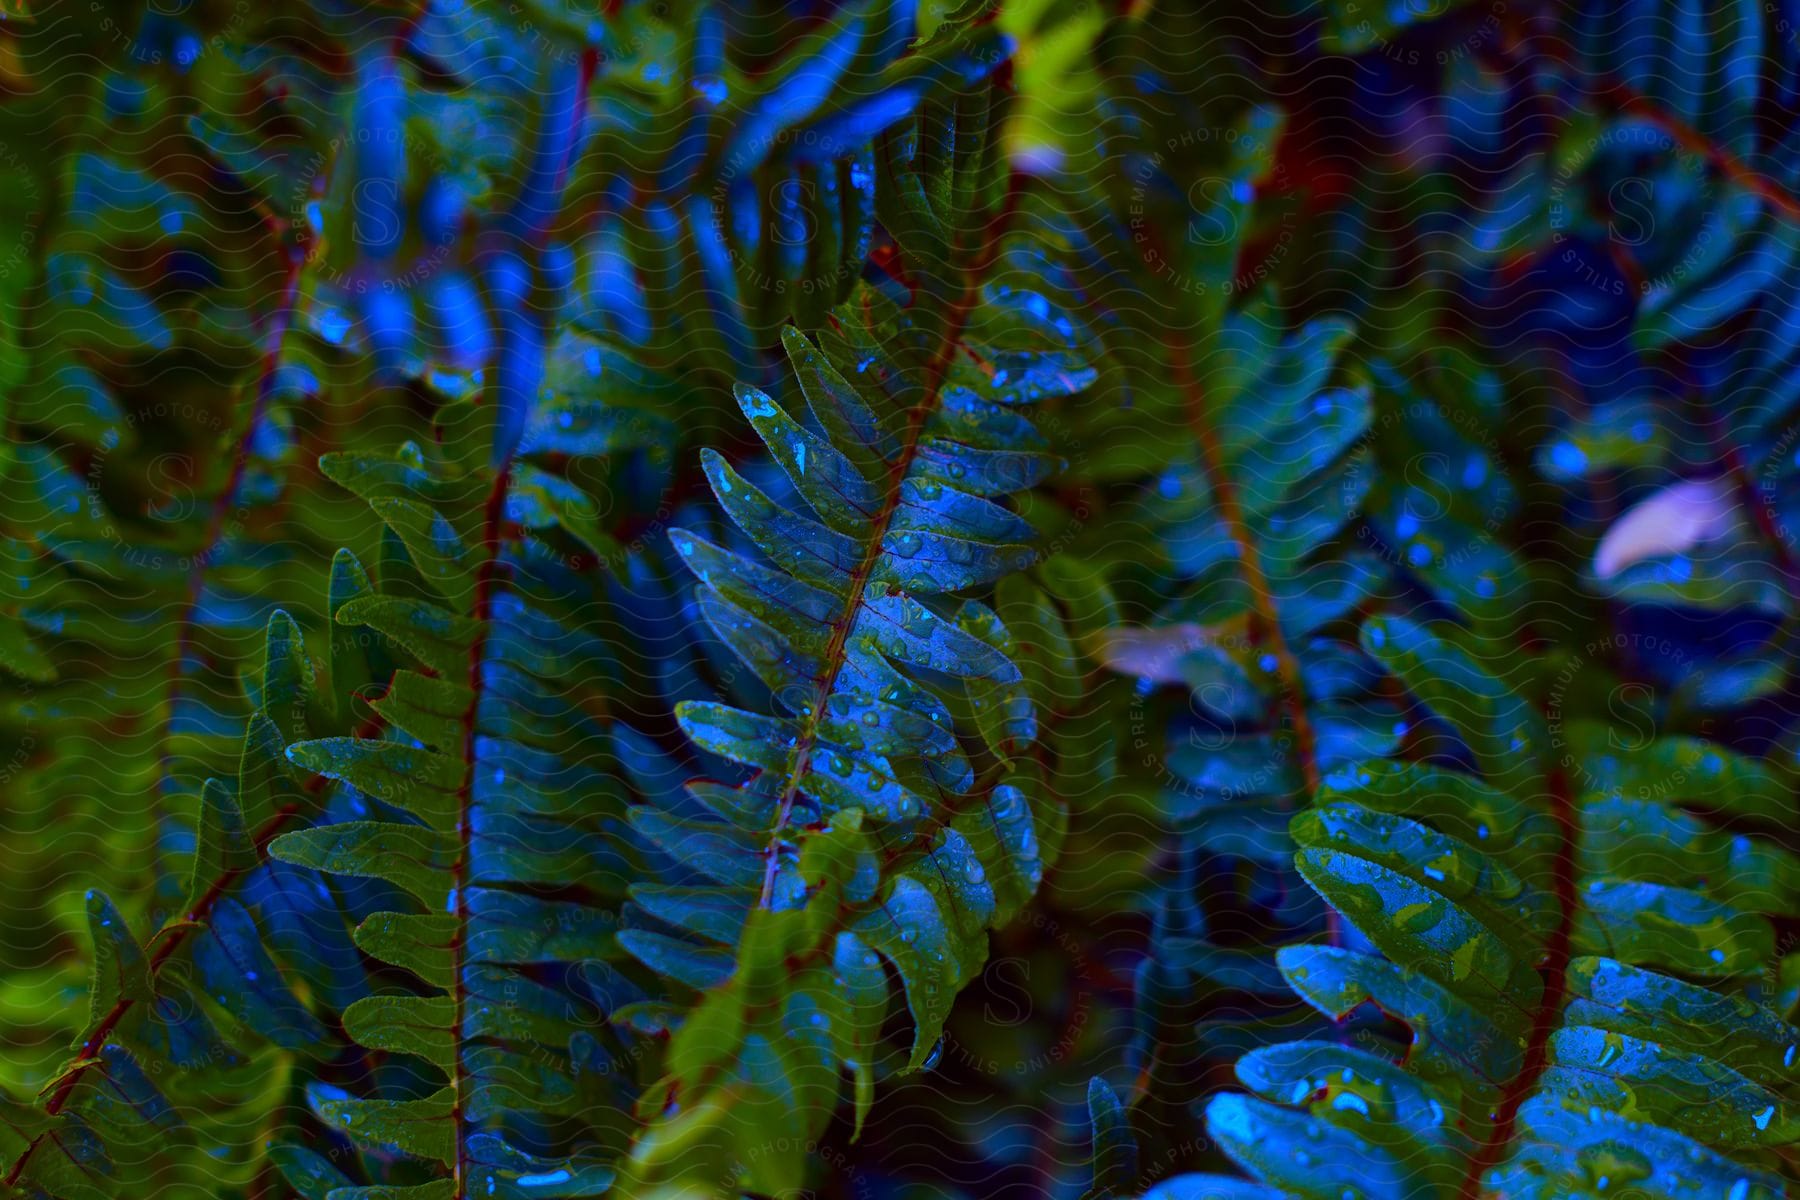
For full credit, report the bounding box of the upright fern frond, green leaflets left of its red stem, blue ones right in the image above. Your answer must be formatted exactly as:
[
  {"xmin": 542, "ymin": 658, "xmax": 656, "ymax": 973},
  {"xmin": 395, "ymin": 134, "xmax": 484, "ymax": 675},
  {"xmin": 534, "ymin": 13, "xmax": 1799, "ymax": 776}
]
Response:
[{"xmin": 270, "ymin": 398, "xmax": 662, "ymax": 1196}]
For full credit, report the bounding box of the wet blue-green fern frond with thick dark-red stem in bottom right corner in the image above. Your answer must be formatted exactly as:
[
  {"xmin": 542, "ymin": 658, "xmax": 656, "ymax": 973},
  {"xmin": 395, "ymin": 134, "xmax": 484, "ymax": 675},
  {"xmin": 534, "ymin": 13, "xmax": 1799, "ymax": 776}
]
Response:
[{"xmin": 1173, "ymin": 617, "xmax": 1800, "ymax": 1196}]
